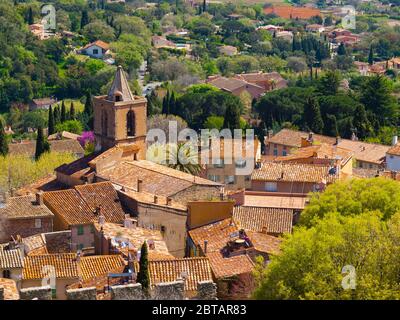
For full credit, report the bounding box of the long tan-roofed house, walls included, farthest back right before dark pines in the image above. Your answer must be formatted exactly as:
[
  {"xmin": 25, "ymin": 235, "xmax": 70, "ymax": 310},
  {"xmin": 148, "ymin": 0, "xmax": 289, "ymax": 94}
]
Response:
[{"xmin": 265, "ymin": 129, "xmax": 390, "ymax": 170}]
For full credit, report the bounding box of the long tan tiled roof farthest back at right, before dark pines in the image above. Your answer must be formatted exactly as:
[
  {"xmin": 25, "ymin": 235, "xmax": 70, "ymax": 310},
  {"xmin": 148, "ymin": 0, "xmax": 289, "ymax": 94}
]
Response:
[{"xmin": 266, "ymin": 129, "xmax": 390, "ymax": 164}]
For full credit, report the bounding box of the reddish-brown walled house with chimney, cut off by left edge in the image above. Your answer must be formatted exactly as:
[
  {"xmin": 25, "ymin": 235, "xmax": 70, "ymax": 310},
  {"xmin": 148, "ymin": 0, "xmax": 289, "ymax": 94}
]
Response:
[{"xmin": 0, "ymin": 193, "xmax": 54, "ymax": 243}]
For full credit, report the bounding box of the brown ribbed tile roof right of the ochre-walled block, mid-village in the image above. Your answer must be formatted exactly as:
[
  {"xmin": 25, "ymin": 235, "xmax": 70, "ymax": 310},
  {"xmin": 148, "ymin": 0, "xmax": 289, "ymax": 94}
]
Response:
[{"xmin": 233, "ymin": 206, "xmax": 293, "ymax": 234}]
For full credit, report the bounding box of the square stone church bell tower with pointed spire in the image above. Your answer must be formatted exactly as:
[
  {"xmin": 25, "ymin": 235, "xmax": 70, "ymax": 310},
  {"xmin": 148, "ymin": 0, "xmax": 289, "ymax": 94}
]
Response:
[{"xmin": 93, "ymin": 66, "xmax": 147, "ymax": 159}]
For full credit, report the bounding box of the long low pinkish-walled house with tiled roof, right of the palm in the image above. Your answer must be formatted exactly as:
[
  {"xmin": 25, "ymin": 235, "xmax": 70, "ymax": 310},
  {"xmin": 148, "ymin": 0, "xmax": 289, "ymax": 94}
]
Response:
[{"xmin": 251, "ymin": 161, "xmax": 339, "ymax": 194}]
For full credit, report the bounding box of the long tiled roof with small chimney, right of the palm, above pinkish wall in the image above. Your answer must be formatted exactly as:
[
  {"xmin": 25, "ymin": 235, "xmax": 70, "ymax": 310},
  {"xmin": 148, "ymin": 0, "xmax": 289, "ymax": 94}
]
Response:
[{"xmin": 251, "ymin": 162, "xmax": 338, "ymax": 183}]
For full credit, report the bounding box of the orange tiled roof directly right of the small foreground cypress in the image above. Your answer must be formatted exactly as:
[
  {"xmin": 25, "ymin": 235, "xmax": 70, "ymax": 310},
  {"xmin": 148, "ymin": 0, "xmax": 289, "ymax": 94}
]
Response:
[{"xmin": 149, "ymin": 257, "xmax": 212, "ymax": 291}]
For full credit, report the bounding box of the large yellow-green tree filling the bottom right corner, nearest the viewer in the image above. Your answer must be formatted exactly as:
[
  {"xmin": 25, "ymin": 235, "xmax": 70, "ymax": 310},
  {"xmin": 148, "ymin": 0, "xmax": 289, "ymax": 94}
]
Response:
[{"xmin": 254, "ymin": 212, "xmax": 400, "ymax": 300}]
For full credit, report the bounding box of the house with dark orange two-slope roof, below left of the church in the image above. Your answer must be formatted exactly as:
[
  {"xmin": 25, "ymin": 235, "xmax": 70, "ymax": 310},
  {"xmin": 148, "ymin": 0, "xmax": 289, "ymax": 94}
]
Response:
[{"xmin": 43, "ymin": 182, "xmax": 125, "ymax": 251}]
